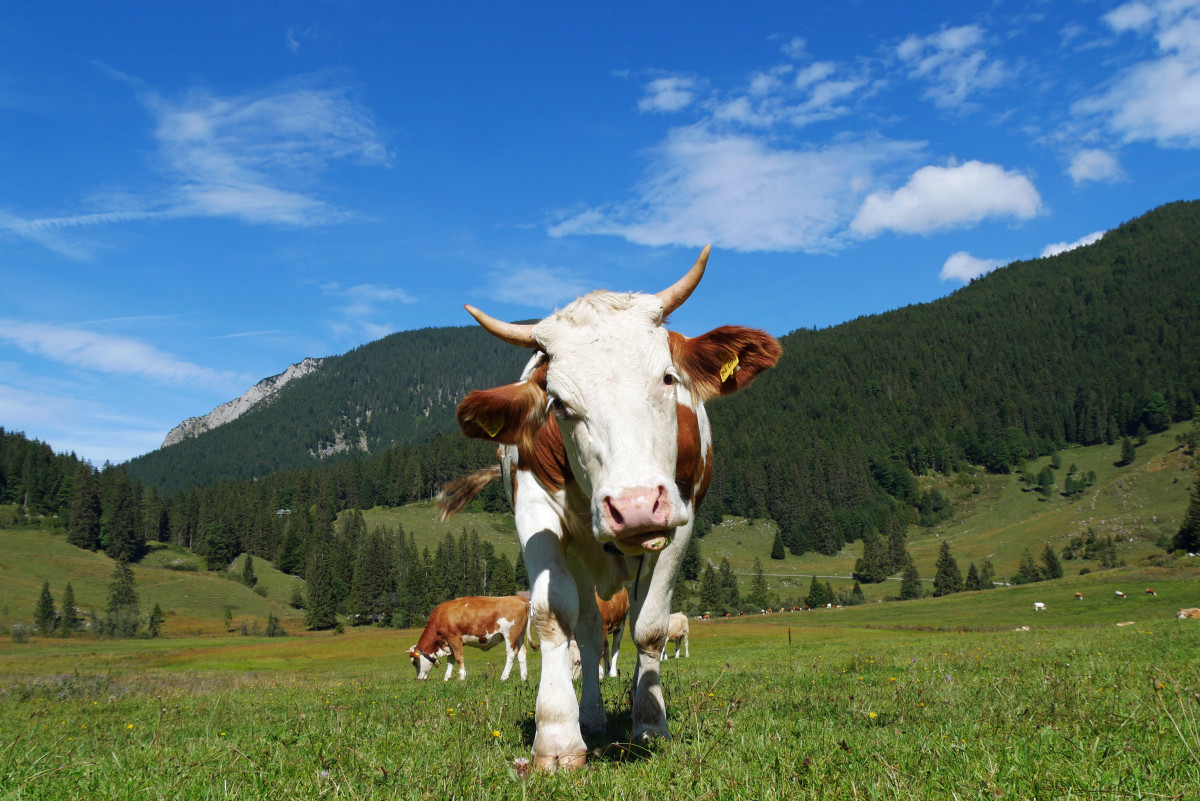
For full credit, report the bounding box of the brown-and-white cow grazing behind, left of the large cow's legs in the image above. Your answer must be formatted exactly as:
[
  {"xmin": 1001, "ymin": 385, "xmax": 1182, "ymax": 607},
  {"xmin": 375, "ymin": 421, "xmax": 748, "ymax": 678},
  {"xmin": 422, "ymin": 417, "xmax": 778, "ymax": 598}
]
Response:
[{"xmin": 408, "ymin": 595, "xmax": 529, "ymax": 681}]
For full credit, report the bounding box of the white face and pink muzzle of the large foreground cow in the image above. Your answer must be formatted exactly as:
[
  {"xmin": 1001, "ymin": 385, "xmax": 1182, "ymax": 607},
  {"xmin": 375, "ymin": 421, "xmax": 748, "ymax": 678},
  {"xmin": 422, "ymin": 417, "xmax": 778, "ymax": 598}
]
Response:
[{"xmin": 534, "ymin": 293, "xmax": 691, "ymax": 554}]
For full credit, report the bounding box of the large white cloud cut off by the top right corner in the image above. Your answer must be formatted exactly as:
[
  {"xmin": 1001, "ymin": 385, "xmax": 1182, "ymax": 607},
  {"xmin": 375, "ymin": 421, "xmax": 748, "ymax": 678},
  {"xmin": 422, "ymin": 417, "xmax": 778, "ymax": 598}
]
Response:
[{"xmin": 1073, "ymin": 0, "xmax": 1200, "ymax": 149}]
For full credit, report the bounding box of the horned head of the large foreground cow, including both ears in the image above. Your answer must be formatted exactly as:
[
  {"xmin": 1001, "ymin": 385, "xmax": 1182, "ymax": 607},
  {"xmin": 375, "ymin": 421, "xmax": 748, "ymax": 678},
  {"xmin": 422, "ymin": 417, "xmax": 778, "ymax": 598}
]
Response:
[{"xmin": 458, "ymin": 247, "xmax": 780, "ymax": 555}]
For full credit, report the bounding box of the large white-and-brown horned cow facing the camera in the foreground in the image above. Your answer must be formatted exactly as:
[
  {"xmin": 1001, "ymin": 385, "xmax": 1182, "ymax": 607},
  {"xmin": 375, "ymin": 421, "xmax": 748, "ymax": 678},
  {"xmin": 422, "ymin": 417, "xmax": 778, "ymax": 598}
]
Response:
[{"xmin": 442, "ymin": 246, "xmax": 781, "ymax": 771}]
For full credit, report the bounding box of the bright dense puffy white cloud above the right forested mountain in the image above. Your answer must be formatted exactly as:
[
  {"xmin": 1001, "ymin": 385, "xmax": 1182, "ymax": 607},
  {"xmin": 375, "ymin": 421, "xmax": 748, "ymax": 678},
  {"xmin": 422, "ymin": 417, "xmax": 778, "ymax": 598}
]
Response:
[{"xmin": 851, "ymin": 161, "xmax": 1042, "ymax": 236}]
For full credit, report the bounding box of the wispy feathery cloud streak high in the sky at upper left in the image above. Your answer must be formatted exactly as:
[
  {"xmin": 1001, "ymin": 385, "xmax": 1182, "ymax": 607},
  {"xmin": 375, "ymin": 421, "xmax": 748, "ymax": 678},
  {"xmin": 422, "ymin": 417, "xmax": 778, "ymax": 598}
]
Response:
[{"xmin": 0, "ymin": 70, "xmax": 390, "ymax": 260}]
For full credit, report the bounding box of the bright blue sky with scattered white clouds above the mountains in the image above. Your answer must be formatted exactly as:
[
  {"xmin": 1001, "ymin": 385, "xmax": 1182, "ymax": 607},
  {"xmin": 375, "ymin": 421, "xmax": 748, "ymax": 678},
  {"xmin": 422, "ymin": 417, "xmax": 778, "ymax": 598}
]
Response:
[{"xmin": 0, "ymin": 0, "xmax": 1200, "ymax": 464}]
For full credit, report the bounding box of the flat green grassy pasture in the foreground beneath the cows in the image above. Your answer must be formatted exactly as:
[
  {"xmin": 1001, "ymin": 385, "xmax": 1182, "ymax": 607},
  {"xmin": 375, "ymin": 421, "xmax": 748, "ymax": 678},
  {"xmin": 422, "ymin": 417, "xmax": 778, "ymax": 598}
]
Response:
[{"xmin": 0, "ymin": 582, "xmax": 1200, "ymax": 801}]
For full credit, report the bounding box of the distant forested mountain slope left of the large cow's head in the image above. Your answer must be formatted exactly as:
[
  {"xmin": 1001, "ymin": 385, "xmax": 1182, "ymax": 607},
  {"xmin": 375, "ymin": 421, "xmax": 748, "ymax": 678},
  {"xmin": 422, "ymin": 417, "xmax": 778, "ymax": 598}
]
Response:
[{"xmin": 126, "ymin": 326, "xmax": 528, "ymax": 492}]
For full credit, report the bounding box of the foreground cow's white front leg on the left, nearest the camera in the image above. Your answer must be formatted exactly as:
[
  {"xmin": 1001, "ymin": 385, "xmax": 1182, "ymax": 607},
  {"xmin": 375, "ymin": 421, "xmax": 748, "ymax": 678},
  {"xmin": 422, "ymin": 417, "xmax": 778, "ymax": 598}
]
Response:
[{"xmin": 517, "ymin": 524, "xmax": 585, "ymax": 771}]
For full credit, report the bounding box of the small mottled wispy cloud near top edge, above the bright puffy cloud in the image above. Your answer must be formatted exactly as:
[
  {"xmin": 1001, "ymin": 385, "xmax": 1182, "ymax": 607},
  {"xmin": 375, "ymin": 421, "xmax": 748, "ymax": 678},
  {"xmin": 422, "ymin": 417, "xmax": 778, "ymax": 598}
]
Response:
[{"xmin": 895, "ymin": 25, "xmax": 1008, "ymax": 109}]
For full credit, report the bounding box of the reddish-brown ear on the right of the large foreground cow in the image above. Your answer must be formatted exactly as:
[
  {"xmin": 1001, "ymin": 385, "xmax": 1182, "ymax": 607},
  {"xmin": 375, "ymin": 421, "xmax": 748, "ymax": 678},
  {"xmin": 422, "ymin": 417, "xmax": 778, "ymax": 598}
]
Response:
[{"xmin": 670, "ymin": 325, "xmax": 782, "ymax": 401}]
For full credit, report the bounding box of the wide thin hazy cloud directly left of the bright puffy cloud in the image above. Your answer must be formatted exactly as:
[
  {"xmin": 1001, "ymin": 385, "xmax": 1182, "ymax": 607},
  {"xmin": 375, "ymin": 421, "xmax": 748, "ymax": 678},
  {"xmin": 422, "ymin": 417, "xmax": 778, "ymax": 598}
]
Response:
[{"xmin": 550, "ymin": 126, "xmax": 922, "ymax": 252}]
